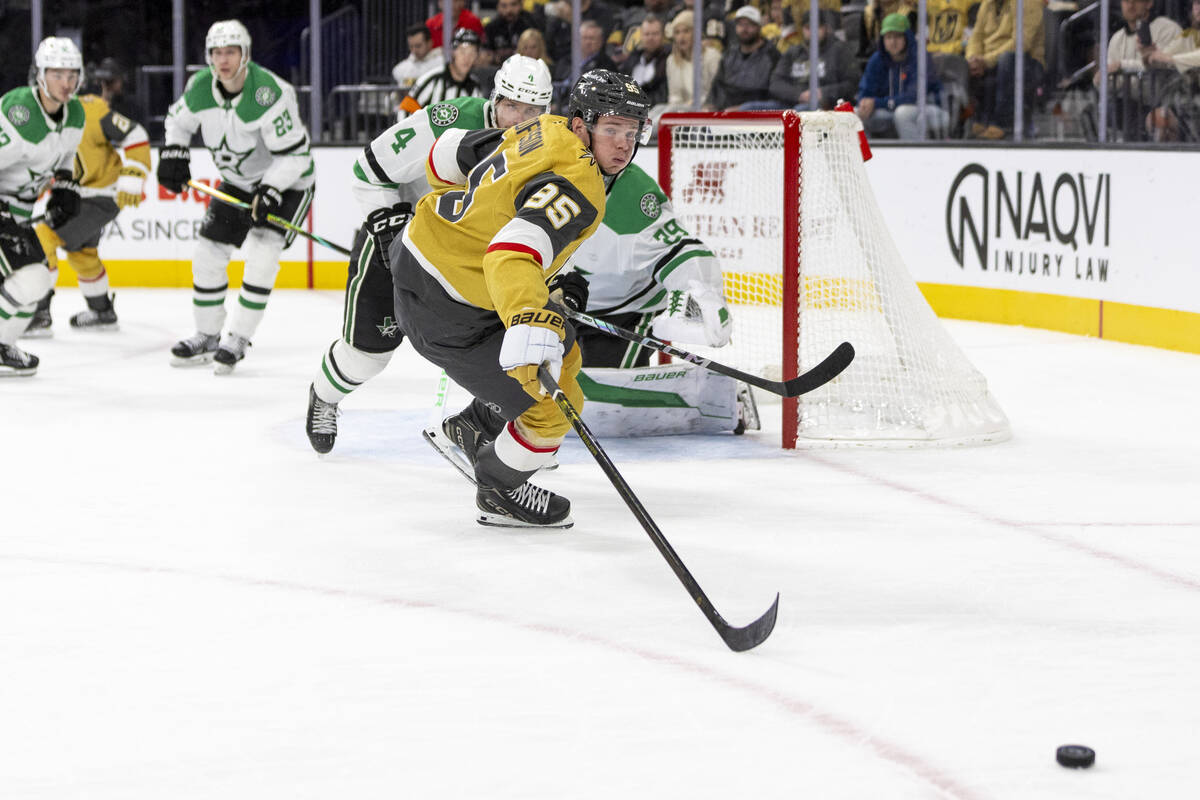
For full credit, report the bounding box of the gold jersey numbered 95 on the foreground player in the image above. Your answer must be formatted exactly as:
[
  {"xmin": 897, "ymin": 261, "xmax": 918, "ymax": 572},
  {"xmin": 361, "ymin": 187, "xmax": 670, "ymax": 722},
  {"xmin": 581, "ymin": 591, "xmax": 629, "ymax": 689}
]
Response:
[{"xmin": 403, "ymin": 114, "xmax": 605, "ymax": 326}]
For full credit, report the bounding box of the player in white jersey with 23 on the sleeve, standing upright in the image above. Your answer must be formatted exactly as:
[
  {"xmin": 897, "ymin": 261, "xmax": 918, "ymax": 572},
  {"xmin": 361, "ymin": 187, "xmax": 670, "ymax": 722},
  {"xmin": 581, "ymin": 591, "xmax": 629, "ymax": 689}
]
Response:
[{"xmin": 158, "ymin": 19, "xmax": 316, "ymax": 374}]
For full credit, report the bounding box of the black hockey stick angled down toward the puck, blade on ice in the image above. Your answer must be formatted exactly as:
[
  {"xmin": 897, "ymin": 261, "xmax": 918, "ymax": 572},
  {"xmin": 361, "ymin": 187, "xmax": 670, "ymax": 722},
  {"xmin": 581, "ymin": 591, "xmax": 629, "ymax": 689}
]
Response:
[{"xmin": 538, "ymin": 365, "xmax": 779, "ymax": 652}]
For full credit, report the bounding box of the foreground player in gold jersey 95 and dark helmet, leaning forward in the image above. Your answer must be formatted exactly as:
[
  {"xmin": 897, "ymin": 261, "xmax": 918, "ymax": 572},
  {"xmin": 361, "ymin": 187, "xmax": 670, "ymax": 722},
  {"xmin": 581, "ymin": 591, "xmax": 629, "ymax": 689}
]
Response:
[{"xmin": 381, "ymin": 70, "xmax": 650, "ymax": 528}]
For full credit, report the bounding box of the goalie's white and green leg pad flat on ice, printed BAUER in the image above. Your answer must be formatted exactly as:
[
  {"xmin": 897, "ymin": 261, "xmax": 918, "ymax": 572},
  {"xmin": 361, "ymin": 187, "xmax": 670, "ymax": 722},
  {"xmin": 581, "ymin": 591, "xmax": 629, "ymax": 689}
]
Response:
[{"xmin": 578, "ymin": 363, "xmax": 738, "ymax": 437}]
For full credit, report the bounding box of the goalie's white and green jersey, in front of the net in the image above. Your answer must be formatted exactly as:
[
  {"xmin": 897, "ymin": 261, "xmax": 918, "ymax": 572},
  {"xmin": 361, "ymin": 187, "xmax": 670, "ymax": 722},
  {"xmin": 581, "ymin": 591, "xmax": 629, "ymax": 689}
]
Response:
[{"xmin": 568, "ymin": 164, "xmax": 724, "ymax": 315}]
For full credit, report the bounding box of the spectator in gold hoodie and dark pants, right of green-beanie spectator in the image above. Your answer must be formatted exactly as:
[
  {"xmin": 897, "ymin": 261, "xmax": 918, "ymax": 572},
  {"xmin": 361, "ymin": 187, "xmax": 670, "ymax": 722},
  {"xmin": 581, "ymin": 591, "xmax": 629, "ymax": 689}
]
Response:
[{"xmin": 966, "ymin": 0, "xmax": 1045, "ymax": 139}]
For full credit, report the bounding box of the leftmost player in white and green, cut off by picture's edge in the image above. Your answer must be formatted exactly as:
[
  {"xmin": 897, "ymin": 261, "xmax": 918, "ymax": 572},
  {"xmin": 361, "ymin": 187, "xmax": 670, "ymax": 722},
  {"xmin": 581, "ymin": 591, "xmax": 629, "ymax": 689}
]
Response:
[{"xmin": 0, "ymin": 36, "xmax": 84, "ymax": 377}]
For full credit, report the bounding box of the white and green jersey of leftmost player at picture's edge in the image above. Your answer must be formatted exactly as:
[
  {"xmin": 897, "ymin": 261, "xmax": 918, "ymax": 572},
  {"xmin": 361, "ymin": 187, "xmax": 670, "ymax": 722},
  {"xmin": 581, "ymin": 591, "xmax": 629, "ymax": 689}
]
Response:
[{"xmin": 0, "ymin": 86, "xmax": 84, "ymax": 217}]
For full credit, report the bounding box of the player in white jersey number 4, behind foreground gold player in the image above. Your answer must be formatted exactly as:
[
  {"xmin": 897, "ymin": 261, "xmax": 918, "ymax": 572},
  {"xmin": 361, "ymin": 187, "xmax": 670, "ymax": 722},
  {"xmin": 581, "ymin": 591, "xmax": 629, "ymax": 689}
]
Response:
[{"xmin": 305, "ymin": 55, "xmax": 553, "ymax": 453}]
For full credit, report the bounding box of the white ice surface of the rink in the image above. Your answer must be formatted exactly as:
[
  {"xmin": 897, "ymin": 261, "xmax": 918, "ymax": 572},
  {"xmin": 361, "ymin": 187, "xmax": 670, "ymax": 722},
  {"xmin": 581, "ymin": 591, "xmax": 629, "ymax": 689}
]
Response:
[{"xmin": 0, "ymin": 289, "xmax": 1200, "ymax": 800}]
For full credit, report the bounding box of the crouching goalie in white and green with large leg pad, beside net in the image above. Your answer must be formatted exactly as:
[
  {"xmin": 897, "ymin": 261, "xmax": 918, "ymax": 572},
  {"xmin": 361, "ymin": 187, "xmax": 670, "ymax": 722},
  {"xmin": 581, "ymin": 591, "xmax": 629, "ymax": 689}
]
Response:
[{"xmin": 559, "ymin": 164, "xmax": 758, "ymax": 437}]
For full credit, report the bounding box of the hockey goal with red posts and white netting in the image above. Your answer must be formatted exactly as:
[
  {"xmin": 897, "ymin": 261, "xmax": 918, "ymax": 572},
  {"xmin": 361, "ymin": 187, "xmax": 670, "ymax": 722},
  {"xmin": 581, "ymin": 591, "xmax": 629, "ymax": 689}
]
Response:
[{"xmin": 659, "ymin": 112, "xmax": 1009, "ymax": 447}]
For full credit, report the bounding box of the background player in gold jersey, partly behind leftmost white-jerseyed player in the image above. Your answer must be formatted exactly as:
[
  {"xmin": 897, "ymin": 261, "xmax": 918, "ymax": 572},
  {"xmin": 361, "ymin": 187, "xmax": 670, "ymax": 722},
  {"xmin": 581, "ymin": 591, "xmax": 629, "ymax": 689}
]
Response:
[{"xmin": 25, "ymin": 95, "xmax": 150, "ymax": 336}]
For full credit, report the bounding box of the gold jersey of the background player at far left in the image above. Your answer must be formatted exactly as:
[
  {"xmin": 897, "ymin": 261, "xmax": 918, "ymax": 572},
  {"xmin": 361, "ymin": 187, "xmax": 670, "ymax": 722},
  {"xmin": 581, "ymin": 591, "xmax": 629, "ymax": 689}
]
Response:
[{"xmin": 74, "ymin": 95, "xmax": 150, "ymax": 196}]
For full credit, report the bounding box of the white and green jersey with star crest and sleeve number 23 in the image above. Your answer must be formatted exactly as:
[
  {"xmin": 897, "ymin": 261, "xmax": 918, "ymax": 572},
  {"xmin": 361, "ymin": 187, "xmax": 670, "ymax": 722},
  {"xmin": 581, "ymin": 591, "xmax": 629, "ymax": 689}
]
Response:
[{"xmin": 166, "ymin": 61, "xmax": 316, "ymax": 192}]
